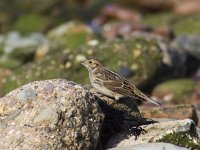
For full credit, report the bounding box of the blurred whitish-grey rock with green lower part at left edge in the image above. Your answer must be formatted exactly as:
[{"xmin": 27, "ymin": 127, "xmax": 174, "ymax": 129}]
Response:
[{"xmin": 0, "ymin": 32, "xmax": 47, "ymax": 68}]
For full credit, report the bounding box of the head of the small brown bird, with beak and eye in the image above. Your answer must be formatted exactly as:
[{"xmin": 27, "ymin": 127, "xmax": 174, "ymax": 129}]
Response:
[{"xmin": 81, "ymin": 59, "xmax": 103, "ymax": 71}]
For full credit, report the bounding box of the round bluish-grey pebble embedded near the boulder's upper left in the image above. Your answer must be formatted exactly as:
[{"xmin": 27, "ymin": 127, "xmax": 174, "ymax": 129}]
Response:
[{"xmin": 17, "ymin": 88, "xmax": 37, "ymax": 103}]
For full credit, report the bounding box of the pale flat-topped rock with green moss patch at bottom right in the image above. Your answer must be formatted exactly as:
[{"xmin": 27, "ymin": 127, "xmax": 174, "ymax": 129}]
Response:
[{"xmin": 107, "ymin": 119, "xmax": 200, "ymax": 149}]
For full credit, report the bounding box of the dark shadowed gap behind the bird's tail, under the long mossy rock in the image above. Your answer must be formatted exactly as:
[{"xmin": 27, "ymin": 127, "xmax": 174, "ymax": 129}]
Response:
[{"xmin": 137, "ymin": 54, "xmax": 200, "ymax": 95}]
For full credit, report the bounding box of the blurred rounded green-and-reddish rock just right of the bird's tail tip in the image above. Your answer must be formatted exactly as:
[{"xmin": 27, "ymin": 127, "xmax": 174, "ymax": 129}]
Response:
[{"xmin": 152, "ymin": 79, "xmax": 199, "ymax": 104}]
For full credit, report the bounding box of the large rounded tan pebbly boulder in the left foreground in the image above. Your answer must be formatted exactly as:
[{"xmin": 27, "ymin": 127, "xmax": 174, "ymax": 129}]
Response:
[{"xmin": 0, "ymin": 79, "xmax": 103, "ymax": 150}]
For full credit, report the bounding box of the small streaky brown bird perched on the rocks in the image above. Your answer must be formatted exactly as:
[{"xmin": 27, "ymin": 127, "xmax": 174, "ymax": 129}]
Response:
[{"xmin": 81, "ymin": 59, "xmax": 160, "ymax": 105}]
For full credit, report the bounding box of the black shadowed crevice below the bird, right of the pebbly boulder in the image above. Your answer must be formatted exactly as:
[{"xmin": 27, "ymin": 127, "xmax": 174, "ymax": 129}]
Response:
[{"xmin": 96, "ymin": 96, "xmax": 156, "ymax": 150}]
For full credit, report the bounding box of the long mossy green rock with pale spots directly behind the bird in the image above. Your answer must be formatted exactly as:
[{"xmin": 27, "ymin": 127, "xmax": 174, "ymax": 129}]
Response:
[{"xmin": 3, "ymin": 37, "xmax": 162, "ymax": 93}]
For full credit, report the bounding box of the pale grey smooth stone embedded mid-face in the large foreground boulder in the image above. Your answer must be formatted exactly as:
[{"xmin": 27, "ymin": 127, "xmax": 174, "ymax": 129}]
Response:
[{"xmin": 34, "ymin": 107, "xmax": 58, "ymax": 125}]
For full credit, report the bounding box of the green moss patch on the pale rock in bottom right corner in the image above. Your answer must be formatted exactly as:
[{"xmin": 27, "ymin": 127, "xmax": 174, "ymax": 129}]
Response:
[{"xmin": 156, "ymin": 132, "xmax": 200, "ymax": 150}]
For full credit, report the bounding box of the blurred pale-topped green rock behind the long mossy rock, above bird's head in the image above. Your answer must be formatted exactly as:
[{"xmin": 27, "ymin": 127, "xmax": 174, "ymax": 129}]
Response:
[{"xmin": 47, "ymin": 21, "xmax": 95, "ymax": 51}]
